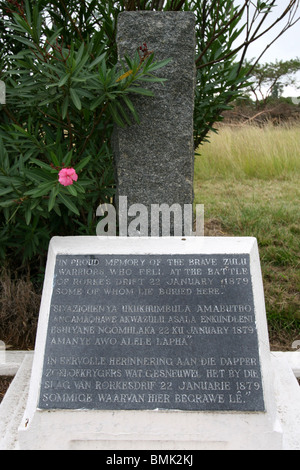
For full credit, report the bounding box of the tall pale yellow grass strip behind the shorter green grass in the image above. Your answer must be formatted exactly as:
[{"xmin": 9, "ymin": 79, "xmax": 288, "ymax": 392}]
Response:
[{"xmin": 195, "ymin": 126, "xmax": 300, "ymax": 179}]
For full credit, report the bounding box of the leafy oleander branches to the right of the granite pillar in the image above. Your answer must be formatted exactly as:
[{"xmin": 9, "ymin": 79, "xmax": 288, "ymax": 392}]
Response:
[{"xmin": 194, "ymin": 0, "xmax": 299, "ymax": 147}]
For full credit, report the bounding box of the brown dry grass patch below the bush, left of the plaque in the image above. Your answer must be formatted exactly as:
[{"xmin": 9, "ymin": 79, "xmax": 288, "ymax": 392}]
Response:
[{"xmin": 0, "ymin": 271, "xmax": 40, "ymax": 349}]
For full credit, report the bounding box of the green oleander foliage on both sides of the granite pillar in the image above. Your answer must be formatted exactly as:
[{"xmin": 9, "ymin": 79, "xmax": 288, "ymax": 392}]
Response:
[{"xmin": 0, "ymin": 0, "xmax": 300, "ymax": 263}]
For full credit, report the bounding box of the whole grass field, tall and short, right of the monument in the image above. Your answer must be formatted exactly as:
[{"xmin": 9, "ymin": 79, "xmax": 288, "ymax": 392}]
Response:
[{"xmin": 195, "ymin": 126, "xmax": 300, "ymax": 349}]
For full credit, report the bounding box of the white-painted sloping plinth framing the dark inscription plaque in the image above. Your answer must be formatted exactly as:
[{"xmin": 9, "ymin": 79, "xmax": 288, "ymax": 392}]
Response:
[{"xmin": 19, "ymin": 237, "xmax": 288, "ymax": 450}]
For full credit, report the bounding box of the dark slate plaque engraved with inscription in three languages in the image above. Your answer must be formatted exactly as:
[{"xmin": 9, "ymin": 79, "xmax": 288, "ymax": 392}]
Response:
[{"xmin": 39, "ymin": 254, "xmax": 265, "ymax": 412}]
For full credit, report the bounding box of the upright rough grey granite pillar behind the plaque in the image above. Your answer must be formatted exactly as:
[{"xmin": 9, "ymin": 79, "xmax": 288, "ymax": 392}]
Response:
[{"xmin": 114, "ymin": 11, "xmax": 195, "ymax": 216}]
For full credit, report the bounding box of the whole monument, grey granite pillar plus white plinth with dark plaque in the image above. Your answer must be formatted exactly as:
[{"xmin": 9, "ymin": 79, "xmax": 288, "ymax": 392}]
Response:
[{"xmin": 18, "ymin": 12, "xmax": 297, "ymax": 450}]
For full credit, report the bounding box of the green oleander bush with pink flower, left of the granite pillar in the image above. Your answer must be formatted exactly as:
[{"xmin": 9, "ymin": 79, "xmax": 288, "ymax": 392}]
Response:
[{"xmin": 0, "ymin": 0, "xmax": 171, "ymax": 268}]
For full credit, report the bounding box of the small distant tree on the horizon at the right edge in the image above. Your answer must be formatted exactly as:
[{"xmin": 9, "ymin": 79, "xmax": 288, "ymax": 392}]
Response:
[{"xmin": 249, "ymin": 57, "xmax": 300, "ymax": 104}]
